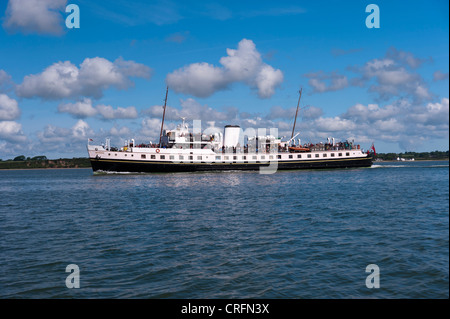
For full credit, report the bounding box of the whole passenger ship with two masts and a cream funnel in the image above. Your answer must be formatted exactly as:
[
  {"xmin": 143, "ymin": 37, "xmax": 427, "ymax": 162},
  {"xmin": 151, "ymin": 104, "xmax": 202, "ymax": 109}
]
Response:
[{"xmin": 87, "ymin": 91, "xmax": 373, "ymax": 174}]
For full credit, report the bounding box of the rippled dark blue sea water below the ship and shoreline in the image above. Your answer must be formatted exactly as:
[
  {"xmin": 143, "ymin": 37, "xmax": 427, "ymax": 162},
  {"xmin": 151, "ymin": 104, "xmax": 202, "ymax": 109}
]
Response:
[{"xmin": 0, "ymin": 161, "xmax": 449, "ymax": 299}]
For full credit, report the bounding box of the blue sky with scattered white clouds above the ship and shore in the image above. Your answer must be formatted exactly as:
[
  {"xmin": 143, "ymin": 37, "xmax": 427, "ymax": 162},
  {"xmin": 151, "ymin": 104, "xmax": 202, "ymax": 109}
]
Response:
[{"xmin": 0, "ymin": 0, "xmax": 449, "ymax": 160}]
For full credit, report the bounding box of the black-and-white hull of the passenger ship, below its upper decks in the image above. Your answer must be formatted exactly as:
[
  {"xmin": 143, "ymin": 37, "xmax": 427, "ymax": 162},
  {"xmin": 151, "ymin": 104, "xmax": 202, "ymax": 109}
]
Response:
[{"xmin": 88, "ymin": 145, "xmax": 372, "ymax": 172}]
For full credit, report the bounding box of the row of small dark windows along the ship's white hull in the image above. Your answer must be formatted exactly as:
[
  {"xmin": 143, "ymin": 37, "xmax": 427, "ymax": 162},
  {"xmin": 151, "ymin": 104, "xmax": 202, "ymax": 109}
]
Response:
[{"xmin": 108, "ymin": 152, "xmax": 350, "ymax": 161}]
